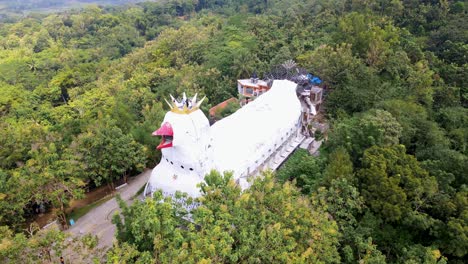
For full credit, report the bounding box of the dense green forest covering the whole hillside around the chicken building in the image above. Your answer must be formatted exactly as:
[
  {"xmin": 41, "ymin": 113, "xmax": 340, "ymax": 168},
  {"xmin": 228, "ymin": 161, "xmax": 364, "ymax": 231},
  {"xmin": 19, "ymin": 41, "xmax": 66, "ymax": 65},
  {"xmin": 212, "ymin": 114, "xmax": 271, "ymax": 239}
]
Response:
[{"xmin": 0, "ymin": 0, "xmax": 468, "ymax": 263}]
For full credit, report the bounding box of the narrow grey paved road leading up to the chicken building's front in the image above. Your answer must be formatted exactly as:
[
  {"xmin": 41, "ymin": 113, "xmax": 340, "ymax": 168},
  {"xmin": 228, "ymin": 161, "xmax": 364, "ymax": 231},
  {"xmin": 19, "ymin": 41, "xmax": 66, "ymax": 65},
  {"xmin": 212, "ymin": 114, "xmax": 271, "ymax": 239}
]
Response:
[{"xmin": 67, "ymin": 170, "xmax": 151, "ymax": 248}]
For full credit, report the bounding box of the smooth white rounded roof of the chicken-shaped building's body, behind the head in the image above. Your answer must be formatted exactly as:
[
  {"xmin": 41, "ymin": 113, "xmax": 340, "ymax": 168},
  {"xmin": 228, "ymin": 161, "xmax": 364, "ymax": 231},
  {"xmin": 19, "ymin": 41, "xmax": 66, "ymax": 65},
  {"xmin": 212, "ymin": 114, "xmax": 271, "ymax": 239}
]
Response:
[{"xmin": 211, "ymin": 80, "xmax": 301, "ymax": 177}]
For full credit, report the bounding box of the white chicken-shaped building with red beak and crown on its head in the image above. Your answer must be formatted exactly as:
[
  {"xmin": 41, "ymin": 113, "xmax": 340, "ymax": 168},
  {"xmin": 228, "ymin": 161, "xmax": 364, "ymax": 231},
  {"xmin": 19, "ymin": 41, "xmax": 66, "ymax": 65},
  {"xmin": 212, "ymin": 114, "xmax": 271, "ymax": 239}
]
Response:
[{"xmin": 144, "ymin": 80, "xmax": 315, "ymax": 197}]
